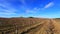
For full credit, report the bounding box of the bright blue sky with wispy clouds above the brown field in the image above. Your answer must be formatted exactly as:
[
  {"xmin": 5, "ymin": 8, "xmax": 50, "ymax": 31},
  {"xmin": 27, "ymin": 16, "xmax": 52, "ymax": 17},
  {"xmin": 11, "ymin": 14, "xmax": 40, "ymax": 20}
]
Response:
[{"xmin": 0, "ymin": 0, "xmax": 60, "ymax": 18}]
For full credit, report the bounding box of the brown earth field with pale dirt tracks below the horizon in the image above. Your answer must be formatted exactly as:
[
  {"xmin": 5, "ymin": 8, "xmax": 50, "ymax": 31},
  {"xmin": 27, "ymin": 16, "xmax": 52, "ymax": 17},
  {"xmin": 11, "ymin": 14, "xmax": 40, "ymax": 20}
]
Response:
[{"xmin": 0, "ymin": 18, "xmax": 60, "ymax": 34}]
